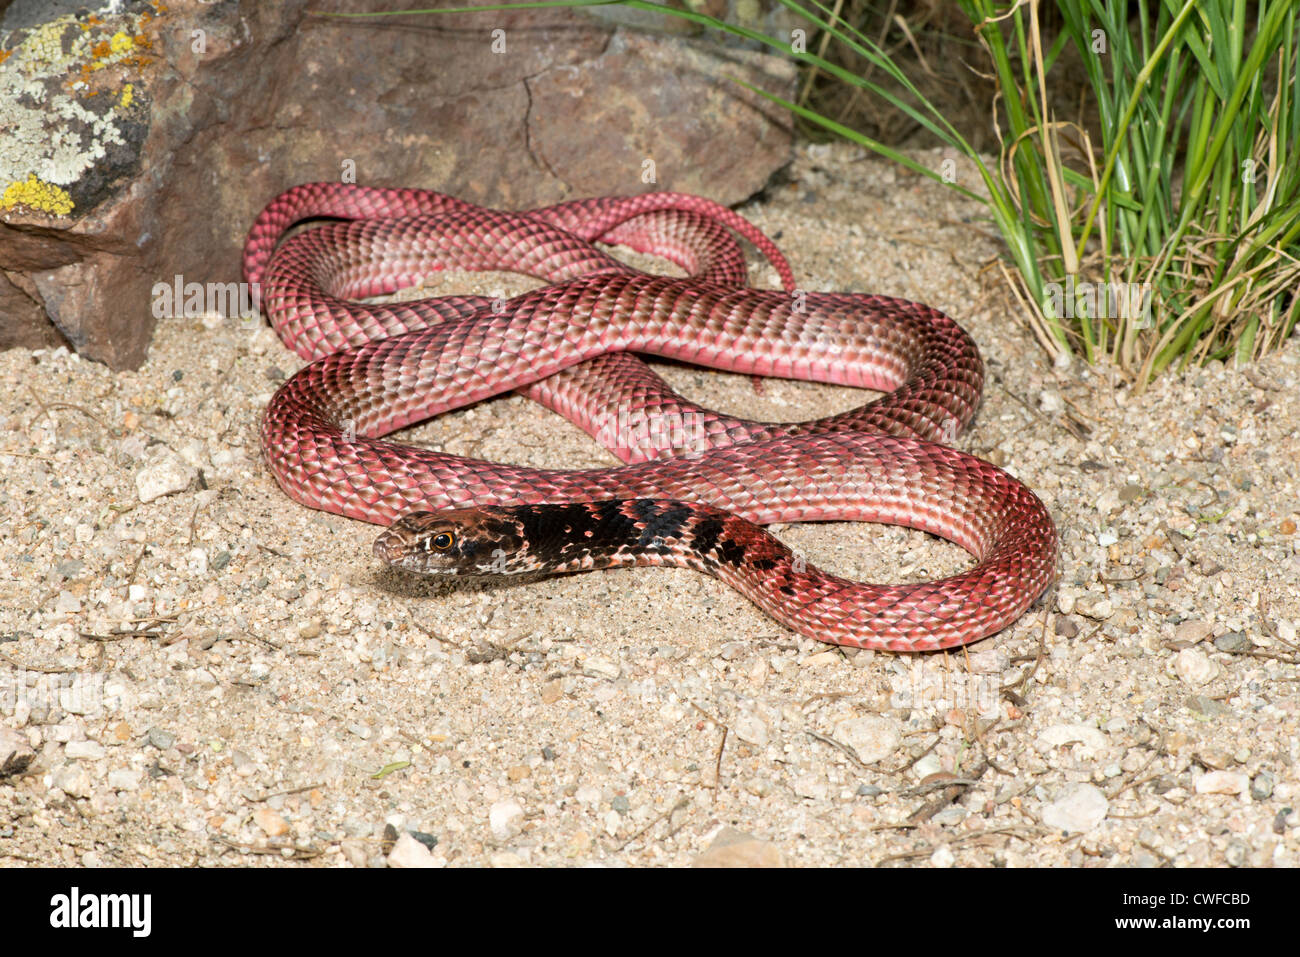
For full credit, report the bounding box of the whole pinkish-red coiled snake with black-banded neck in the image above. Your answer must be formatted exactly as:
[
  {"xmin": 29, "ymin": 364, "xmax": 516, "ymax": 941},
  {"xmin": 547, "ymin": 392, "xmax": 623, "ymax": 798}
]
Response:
[{"xmin": 243, "ymin": 183, "xmax": 1058, "ymax": 651}]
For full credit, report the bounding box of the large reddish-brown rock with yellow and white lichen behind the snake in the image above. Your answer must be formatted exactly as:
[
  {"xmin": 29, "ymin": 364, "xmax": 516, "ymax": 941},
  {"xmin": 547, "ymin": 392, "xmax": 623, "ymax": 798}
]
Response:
[{"xmin": 0, "ymin": 0, "xmax": 797, "ymax": 368}]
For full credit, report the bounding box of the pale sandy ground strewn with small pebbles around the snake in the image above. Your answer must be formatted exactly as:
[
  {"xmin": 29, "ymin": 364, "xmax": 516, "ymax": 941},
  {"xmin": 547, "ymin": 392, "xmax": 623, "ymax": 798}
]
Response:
[{"xmin": 0, "ymin": 147, "xmax": 1300, "ymax": 867}]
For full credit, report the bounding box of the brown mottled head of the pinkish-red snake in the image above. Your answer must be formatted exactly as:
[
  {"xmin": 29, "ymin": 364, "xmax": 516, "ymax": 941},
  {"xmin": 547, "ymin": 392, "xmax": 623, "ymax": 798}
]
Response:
[{"xmin": 374, "ymin": 507, "xmax": 534, "ymax": 576}]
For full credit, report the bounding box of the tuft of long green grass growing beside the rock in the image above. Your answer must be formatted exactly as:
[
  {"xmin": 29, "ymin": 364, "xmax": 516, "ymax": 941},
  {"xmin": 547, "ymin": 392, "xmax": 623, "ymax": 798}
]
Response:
[{"xmin": 322, "ymin": 0, "xmax": 1300, "ymax": 387}]
